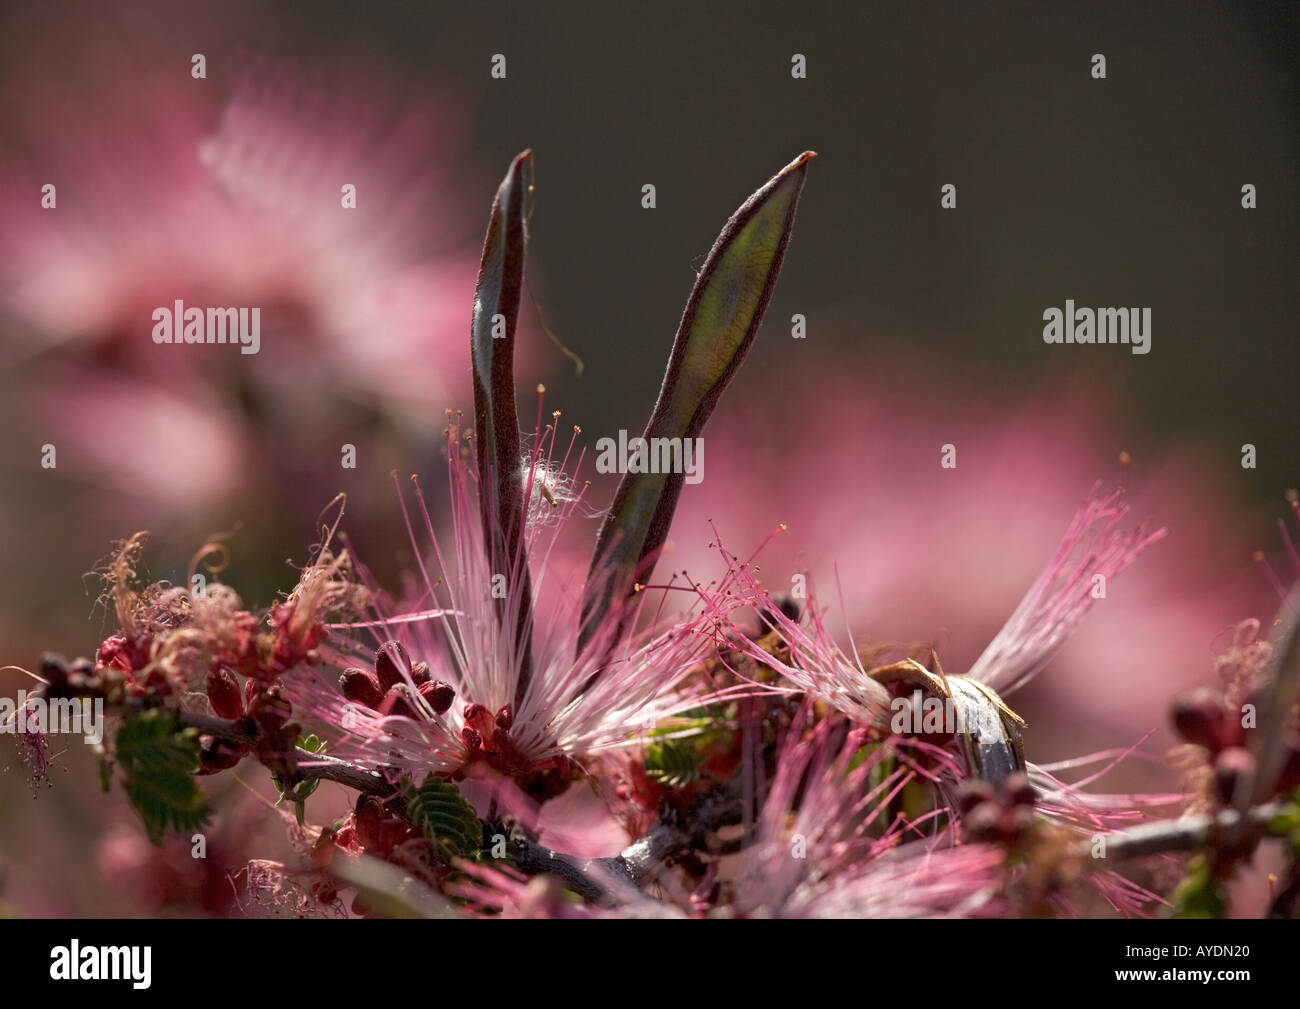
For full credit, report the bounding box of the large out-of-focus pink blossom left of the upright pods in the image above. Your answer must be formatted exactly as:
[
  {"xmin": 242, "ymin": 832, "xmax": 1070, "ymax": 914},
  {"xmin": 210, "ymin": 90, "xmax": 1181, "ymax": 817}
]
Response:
[{"xmin": 0, "ymin": 42, "xmax": 476, "ymax": 507}]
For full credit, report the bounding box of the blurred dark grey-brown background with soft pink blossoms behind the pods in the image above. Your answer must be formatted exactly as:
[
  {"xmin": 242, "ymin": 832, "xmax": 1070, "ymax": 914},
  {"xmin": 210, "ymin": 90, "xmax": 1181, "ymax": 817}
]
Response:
[{"xmin": 0, "ymin": 0, "xmax": 1300, "ymax": 914}]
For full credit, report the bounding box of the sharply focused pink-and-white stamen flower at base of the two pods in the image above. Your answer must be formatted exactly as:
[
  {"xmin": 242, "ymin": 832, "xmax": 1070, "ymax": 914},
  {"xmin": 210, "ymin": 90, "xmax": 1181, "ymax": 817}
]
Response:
[{"xmin": 286, "ymin": 421, "xmax": 754, "ymax": 776}]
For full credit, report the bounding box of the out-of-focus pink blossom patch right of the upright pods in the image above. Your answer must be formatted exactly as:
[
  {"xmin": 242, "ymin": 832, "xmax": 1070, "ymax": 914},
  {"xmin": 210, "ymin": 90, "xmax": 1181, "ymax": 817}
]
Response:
[{"xmin": 657, "ymin": 351, "xmax": 1266, "ymax": 784}]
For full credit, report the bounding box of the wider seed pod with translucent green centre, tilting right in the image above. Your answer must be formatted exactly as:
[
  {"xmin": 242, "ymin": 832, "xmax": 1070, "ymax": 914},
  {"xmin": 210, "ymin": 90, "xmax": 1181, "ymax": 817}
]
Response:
[{"xmin": 581, "ymin": 151, "xmax": 815, "ymax": 646}]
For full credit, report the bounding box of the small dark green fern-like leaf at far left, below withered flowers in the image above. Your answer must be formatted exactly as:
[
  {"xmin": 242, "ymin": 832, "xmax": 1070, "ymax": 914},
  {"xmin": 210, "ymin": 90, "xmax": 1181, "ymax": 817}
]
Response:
[{"xmin": 117, "ymin": 710, "xmax": 211, "ymax": 845}]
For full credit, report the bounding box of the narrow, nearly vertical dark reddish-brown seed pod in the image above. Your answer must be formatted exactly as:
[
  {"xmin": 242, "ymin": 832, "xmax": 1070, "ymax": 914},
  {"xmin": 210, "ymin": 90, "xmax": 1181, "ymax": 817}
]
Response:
[{"xmin": 469, "ymin": 151, "xmax": 533, "ymax": 706}]
